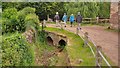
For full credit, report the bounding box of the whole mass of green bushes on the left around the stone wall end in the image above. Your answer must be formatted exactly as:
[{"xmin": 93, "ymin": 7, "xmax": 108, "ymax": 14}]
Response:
[{"xmin": 0, "ymin": 7, "xmax": 39, "ymax": 66}]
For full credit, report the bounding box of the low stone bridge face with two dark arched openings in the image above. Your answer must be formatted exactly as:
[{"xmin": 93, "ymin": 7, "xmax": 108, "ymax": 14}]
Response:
[{"xmin": 45, "ymin": 31, "xmax": 67, "ymax": 47}]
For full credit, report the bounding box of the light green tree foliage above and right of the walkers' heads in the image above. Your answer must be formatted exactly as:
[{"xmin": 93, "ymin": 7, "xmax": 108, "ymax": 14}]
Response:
[{"xmin": 65, "ymin": 2, "xmax": 99, "ymax": 18}]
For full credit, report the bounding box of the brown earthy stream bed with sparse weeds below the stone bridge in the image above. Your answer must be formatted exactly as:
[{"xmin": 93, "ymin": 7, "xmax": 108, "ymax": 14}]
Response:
[{"xmin": 35, "ymin": 45, "xmax": 70, "ymax": 66}]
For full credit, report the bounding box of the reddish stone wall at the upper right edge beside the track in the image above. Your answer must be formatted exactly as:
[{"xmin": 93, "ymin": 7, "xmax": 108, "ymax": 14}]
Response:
[{"xmin": 110, "ymin": 2, "xmax": 118, "ymax": 29}]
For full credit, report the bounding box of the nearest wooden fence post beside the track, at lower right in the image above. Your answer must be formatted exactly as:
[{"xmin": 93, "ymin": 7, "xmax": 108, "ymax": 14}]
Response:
[{"xmin": 96, "ymin": 46, "xmax": 102, "ymax": 66}]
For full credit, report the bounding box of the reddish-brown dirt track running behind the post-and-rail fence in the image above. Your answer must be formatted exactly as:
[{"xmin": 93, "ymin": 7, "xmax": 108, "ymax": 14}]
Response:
[{"xmin": 47, "ymin": 24, "xmax": 118, "ymax": 65}]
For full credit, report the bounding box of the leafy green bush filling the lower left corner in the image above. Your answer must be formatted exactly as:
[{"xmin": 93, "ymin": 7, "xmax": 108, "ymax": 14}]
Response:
[{"xmin": 0, "ymin": 34, "xmax": 34, "ymax": 66}]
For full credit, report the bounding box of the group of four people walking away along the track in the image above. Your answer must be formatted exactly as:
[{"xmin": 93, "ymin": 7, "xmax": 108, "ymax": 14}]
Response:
[{"xmin": 54, "ymin": 12, "xmax": 82, "ymax": 29}]
